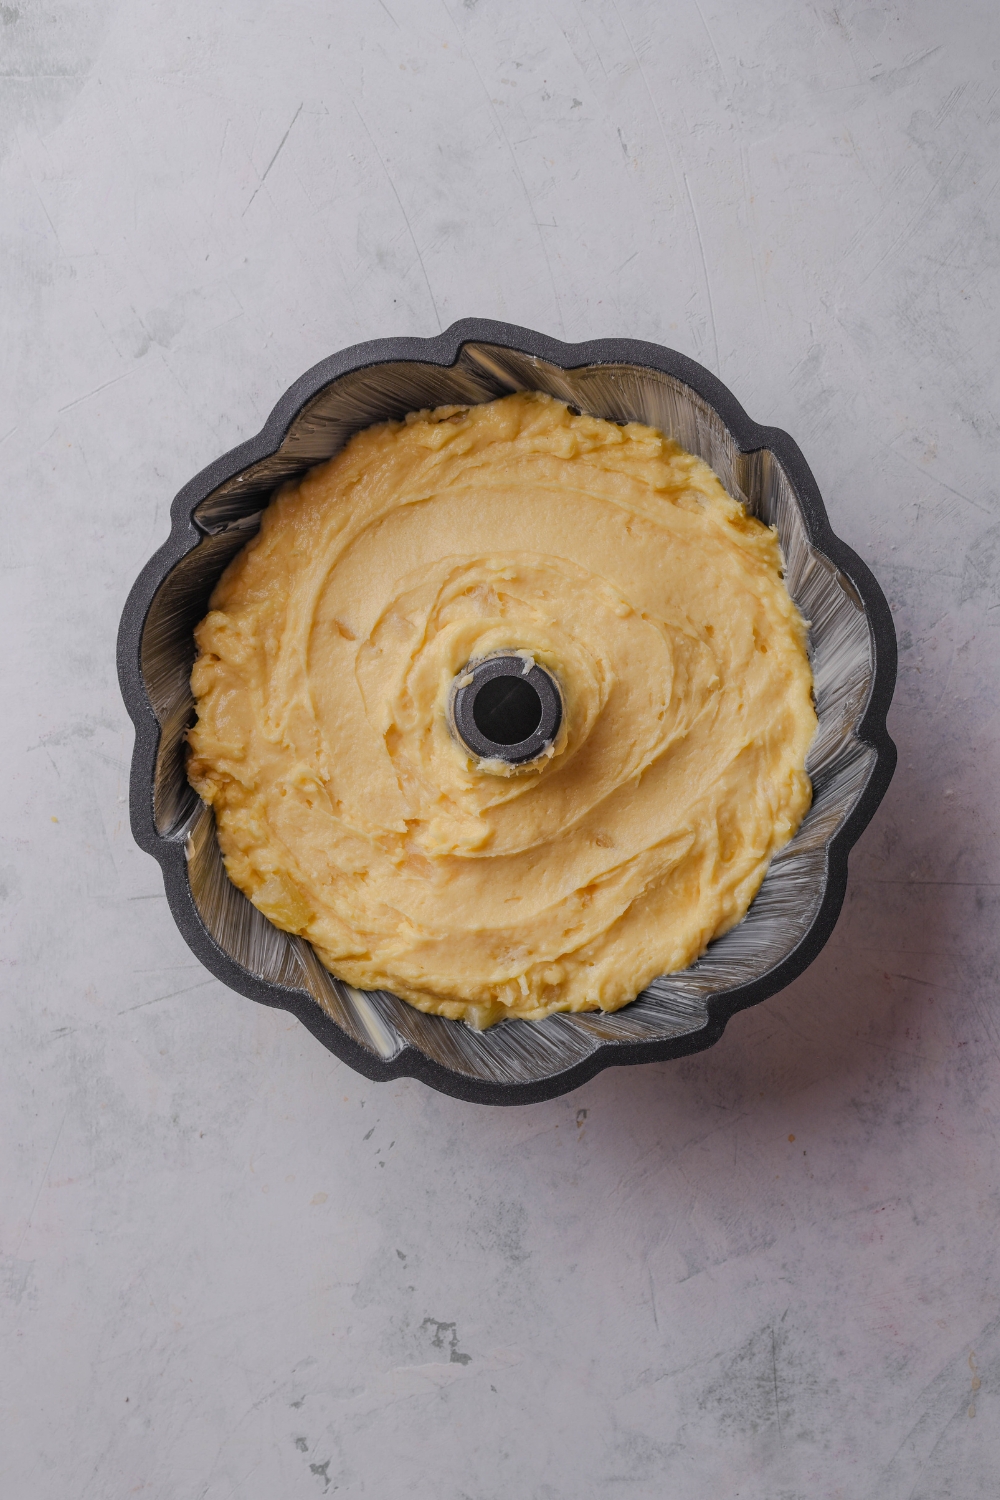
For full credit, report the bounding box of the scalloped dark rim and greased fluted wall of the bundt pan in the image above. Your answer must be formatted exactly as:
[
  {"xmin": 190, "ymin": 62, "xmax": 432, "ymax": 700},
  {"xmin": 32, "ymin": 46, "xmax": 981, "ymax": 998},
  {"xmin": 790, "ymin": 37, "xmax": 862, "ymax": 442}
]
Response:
[{"xmin": 118, "ymin": 320, "xmax": 897, "ymax": 1104}]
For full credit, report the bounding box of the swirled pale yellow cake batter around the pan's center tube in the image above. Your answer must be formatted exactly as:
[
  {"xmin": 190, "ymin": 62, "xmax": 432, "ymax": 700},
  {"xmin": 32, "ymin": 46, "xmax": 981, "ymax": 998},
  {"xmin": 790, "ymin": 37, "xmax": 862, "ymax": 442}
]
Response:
[{"xmin": 189, "ymin": 393, "xmax": 816, "ymax": 1028}]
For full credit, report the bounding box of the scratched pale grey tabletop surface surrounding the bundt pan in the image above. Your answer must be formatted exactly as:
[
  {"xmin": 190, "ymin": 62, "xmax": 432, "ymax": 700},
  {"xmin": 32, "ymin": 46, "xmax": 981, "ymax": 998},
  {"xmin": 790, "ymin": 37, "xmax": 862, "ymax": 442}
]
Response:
[{"xmin": 0, "ymin": 0, "xmax": 1000, "ymax": 1500}]
